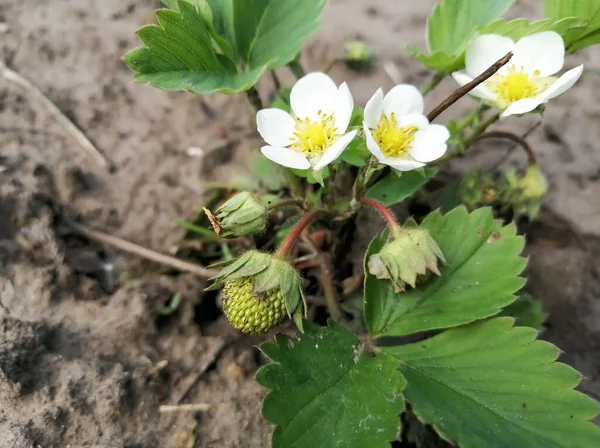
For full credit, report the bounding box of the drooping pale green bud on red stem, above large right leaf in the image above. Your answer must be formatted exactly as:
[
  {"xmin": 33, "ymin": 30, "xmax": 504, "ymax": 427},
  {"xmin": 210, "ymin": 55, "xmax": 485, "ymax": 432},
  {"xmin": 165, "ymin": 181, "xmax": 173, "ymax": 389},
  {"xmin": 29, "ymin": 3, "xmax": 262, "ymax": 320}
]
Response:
[{"xmin": 367, "ymin": 228, "xmax": 445, "ymax": 292}]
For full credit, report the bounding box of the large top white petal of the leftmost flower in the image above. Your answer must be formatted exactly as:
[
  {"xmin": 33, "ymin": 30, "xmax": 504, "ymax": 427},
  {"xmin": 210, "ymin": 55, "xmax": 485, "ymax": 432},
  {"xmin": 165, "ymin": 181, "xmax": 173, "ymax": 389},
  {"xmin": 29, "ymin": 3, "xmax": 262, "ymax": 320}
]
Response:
[{"xmin": 290, "ymin": 72, "xmax": 338, "ymax": 120}]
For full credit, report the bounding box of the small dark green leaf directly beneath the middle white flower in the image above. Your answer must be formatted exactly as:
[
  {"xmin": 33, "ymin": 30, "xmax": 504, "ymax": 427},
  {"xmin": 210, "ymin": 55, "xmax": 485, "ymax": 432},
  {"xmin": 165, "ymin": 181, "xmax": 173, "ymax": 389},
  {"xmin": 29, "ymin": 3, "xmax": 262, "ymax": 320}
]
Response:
[{"xmin": 366, "ymin": 167, "xmax": 438, "ymax": 206}]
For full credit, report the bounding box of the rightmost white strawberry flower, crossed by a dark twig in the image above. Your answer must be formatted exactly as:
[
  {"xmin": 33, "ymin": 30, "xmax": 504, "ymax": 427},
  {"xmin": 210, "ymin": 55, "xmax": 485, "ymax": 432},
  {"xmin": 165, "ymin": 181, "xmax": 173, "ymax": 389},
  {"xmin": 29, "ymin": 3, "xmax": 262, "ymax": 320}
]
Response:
[{"xmin": 452, "ymin": 31, "xmax": 583, "ymax": 118}]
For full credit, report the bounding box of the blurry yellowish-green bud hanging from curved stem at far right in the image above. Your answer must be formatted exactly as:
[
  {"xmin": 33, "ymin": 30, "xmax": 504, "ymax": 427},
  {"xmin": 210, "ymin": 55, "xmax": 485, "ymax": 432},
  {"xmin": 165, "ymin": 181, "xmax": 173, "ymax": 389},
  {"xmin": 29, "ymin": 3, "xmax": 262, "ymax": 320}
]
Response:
[{"xmin": 503, "ymin": 165, "xmax": 548, "ymax": 219}]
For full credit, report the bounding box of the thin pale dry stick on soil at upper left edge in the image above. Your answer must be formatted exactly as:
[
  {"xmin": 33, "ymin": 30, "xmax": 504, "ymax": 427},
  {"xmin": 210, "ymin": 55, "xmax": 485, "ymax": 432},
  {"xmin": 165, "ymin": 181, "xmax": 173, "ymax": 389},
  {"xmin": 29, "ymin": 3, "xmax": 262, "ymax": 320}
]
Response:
[{"xmin": 0, "ymin": 61, "xmax": 108, "ymax": 168}]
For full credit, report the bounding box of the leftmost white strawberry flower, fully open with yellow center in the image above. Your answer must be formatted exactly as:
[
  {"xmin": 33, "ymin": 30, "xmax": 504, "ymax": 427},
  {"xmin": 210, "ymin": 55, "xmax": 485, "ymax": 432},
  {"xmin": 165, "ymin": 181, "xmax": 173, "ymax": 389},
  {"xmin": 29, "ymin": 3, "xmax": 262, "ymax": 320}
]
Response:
[{"xmin": 256, "ymin": 72, "xmax": 356, "ymax": 171}]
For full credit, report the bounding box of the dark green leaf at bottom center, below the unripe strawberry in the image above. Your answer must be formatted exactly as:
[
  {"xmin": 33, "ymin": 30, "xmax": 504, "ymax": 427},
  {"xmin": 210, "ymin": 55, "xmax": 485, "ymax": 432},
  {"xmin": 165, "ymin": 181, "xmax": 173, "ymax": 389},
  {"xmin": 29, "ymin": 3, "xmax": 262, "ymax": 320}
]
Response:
[{"xmin": 256, "ymin": 322, "xmax": 405, "ymax": 448}]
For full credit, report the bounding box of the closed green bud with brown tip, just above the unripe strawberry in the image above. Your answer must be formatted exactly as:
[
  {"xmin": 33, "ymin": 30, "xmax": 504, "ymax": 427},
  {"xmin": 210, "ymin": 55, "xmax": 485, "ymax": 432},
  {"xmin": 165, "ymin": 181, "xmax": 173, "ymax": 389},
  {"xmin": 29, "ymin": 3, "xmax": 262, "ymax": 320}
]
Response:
[{"xmin": 204, "ymin": 191, "xmax": 267, "ymax": 238}]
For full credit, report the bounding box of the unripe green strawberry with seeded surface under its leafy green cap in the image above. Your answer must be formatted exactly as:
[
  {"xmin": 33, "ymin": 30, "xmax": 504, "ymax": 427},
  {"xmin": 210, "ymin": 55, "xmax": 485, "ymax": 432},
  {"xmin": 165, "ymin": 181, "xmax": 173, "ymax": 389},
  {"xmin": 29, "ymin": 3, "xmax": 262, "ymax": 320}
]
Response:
[{"xmin": 208, "ymin": 250, "xmax": 306, "ymax": 334}]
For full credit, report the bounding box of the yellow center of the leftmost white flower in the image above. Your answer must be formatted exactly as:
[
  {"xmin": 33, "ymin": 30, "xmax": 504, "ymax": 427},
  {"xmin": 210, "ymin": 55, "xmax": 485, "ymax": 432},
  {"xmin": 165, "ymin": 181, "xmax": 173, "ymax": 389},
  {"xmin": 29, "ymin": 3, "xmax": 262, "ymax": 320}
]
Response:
[{"xmin": 292, "ymin": 111, "xmax": 337, "ymax": 156}]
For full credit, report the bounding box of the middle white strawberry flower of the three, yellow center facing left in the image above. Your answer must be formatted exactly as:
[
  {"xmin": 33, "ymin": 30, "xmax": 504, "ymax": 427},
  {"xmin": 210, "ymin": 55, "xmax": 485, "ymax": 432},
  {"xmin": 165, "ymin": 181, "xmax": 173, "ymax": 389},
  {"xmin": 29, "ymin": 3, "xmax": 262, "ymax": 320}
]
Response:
[{"xmin": 363, "ymin": 84, "xmax": 450, "ymax": 171}]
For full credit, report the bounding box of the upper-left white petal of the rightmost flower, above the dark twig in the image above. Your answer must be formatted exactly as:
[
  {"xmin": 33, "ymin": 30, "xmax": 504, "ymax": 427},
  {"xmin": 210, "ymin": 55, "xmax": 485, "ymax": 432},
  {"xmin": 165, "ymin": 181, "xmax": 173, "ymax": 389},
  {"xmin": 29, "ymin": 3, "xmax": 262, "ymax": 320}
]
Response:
[{"xmin": 465, "ymin": 34, "xmax": 515, "ymax": 78}]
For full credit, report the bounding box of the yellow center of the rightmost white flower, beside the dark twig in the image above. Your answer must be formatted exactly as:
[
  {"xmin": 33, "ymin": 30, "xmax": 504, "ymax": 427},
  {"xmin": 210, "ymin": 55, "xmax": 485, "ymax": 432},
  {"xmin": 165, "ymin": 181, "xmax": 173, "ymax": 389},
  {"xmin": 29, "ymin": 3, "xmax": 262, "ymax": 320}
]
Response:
[{"xmin": 486, "ymin": 64, "xmax": 551, "ymax": 109}]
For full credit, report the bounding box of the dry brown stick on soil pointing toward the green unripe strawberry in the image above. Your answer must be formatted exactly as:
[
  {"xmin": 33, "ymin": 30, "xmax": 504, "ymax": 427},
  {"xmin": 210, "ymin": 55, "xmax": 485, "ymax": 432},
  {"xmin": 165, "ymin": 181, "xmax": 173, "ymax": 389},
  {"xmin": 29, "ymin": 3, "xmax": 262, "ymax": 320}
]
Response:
[{"xmin": 63, "ymin": 217, "xmax": 219, "ymax": 278}]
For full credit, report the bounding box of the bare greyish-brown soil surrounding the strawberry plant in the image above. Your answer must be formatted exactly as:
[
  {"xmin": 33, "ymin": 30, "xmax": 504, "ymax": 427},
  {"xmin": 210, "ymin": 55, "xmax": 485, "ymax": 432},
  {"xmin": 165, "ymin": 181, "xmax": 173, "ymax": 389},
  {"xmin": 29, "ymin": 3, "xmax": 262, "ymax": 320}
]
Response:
[{"xmin": 0, "ymin": 0, "xmax": 600, "ymax": 448}]
